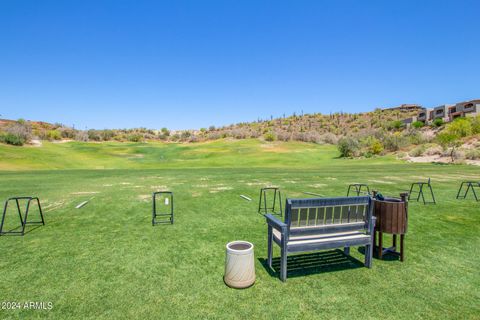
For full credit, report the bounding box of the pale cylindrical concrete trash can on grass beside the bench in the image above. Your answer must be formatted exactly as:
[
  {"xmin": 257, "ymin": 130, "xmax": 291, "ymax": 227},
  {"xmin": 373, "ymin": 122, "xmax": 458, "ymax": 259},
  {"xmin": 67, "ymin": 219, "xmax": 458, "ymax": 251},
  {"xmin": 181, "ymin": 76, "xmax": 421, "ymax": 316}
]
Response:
[{"xmin": 223, "ymin": 241, "xmax": 255, "ymax": 289}]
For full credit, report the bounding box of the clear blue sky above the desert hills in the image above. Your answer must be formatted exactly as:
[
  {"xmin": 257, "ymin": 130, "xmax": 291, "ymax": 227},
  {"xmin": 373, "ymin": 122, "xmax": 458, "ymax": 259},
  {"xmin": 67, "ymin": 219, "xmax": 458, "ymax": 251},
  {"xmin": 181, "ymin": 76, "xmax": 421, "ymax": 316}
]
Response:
[{"xmin": 0, "ymin": 0, "xmax": 480, "ymax": 129}]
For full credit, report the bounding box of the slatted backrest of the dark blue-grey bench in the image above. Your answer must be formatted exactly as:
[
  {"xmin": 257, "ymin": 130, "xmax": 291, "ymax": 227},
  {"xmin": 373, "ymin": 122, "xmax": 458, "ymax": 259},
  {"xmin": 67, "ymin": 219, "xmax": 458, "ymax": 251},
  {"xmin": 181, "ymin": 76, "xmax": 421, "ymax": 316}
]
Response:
[{"xmin": 285, "ymin": 196, "xmax": 371, "ymax": 234}]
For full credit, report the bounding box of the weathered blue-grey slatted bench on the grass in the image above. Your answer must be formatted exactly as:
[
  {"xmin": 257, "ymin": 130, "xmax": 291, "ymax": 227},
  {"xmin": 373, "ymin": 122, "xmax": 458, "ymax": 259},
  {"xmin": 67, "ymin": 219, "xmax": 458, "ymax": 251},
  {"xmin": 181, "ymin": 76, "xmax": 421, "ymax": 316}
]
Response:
[{"xmin": 265, "ymin": 196, "xmax": 375, "ymax": 281}]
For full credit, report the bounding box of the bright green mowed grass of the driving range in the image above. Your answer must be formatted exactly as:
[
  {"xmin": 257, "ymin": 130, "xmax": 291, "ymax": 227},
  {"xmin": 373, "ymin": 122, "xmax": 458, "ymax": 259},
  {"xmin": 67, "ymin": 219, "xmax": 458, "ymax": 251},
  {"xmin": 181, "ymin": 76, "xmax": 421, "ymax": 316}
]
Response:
[{"xmin": 0, "ymin": 140, "xmax": 480, "ymax": 319}]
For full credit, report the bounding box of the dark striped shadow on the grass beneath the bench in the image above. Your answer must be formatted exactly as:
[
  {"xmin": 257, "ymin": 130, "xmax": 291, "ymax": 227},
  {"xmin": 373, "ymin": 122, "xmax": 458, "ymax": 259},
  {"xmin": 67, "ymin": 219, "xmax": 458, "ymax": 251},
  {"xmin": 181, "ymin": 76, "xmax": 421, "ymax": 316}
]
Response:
[{"xmin": 258, "ymin": 249, "xmax": 365, "ymax": 278}]
